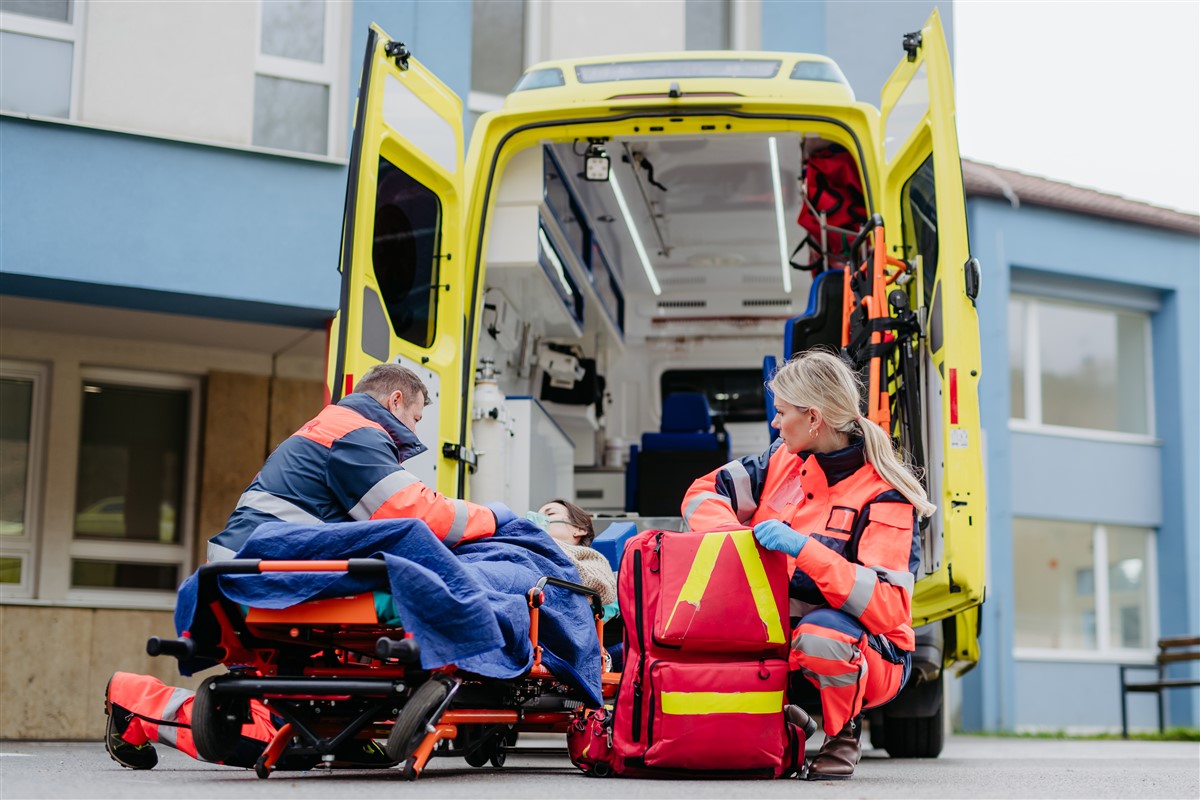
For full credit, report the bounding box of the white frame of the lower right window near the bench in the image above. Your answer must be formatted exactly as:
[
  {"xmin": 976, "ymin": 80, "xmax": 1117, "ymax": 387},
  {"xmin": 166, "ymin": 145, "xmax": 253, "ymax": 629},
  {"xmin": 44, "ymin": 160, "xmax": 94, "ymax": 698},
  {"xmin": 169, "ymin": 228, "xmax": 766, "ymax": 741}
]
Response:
[{"xmin": 1013, "ymin": 517, "xmax": 1160, "ymax": 663}]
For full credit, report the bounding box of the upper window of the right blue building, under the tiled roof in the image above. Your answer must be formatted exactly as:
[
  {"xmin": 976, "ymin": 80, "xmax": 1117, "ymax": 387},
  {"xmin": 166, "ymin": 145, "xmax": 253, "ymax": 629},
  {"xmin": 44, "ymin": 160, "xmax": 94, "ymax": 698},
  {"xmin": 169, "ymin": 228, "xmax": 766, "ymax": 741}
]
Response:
[{"xmin": 1008, "ymin": 295, "xmax": 1154, "ymax": 437}]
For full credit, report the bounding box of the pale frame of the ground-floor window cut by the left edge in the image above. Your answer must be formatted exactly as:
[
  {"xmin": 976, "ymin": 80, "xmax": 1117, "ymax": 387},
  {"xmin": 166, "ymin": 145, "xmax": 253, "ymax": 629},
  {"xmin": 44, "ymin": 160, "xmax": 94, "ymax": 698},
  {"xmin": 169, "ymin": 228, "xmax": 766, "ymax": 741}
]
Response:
[{"xmin": 0, "ymin": 359, "xmax": 50, "ymax": 601}]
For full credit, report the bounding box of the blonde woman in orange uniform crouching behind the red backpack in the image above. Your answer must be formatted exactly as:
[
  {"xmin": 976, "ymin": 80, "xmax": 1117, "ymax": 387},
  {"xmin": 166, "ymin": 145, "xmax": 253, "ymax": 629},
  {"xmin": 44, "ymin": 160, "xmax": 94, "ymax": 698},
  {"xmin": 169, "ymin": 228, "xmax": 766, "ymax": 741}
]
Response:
[{"xmin": 683, "ymin": 351, "xmax": 936, "ymax": 780}]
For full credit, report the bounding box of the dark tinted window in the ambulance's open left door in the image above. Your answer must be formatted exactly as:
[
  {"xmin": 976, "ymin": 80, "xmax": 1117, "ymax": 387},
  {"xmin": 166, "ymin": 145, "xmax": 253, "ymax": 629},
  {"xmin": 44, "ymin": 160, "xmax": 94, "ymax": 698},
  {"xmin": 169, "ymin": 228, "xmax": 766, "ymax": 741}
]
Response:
[{"xmin": 371, "ymin": 157, "xmax": 442, "ymax": 347}]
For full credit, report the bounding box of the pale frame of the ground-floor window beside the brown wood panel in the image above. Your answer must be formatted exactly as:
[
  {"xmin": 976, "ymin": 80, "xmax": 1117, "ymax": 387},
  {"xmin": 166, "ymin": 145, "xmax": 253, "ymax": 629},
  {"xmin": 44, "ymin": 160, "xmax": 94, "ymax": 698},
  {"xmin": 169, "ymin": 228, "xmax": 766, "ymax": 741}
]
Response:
[{"xmin": 56, "ymin": 366, "xmax": 203, "ymax": 608}]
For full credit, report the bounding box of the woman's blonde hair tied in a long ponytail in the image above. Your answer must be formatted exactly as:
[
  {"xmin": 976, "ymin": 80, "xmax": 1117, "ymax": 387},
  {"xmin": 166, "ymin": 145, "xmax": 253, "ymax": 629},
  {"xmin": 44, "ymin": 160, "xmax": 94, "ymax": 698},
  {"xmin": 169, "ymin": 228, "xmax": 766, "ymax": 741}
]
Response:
[{"xmin": 769, "ymin": 350, "xmax": 937, "ymax": 518}]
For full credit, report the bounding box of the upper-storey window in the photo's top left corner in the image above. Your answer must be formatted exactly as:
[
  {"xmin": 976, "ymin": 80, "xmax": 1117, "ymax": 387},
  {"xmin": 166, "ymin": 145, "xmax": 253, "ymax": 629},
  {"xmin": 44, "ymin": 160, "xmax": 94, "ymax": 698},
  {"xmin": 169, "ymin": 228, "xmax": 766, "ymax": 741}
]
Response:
[{"xmin": 0, "ymin": 0, "xmax": 83, "ymax": 119}]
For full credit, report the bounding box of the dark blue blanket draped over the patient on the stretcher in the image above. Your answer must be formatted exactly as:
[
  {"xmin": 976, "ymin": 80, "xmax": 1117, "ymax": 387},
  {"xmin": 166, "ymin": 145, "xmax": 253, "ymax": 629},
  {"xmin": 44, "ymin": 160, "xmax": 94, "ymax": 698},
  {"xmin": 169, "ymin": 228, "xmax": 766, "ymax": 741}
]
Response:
[{"xmin": 175, "ymin": 519, "xmax": 601, "ymax": 706}]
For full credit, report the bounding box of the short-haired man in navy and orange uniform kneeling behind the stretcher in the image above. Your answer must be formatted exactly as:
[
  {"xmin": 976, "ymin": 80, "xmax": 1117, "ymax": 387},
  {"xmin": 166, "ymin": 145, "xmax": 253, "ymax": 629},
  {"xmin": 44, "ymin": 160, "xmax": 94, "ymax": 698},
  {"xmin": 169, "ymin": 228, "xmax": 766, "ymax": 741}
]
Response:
[{"xmin": 104, "ymin": 363, "xmax": 516, "ymax": 769}]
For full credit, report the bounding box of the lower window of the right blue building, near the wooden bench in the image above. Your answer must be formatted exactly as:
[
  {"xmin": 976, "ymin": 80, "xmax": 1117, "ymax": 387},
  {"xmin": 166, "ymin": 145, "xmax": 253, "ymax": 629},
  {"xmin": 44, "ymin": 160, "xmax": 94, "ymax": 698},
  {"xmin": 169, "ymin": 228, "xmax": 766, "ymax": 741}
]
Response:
[{"xmin": 1013, "ymin": 518, "xmax": 1157, "ymax": 655}]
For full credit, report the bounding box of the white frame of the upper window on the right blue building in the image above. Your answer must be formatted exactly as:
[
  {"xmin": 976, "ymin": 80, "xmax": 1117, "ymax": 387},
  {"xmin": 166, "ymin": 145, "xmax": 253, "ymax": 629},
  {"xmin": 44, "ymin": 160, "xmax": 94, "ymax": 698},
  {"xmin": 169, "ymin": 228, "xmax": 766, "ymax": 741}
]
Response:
[{"xmin": 1008, "ymin": 290, "xmax": 1160, "ymax": 445}]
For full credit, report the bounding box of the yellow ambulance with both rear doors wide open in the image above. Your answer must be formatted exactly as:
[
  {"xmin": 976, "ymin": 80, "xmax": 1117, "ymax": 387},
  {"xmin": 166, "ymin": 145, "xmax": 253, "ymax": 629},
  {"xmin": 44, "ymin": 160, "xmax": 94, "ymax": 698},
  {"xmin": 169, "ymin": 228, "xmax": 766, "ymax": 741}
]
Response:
[{"xmin": 329, "ymin": 11, "xmax": 985, "ymax": 757}]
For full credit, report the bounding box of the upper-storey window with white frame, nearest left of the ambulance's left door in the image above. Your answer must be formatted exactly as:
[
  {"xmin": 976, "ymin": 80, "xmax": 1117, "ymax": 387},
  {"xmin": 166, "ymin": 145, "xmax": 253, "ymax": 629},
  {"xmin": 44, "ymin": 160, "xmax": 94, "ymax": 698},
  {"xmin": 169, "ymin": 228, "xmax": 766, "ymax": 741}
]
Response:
[{"xmin": 252, "ymin": 0, "xmax": 341, "ymax": 156}]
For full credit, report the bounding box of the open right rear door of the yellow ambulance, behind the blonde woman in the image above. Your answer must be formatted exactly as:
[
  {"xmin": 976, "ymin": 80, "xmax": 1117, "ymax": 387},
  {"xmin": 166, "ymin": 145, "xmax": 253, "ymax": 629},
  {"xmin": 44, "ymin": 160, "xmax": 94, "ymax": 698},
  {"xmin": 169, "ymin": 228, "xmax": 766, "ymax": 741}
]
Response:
[{"xmin": 880, "ymin": 10, "xmax": 985, "ymax": 667}]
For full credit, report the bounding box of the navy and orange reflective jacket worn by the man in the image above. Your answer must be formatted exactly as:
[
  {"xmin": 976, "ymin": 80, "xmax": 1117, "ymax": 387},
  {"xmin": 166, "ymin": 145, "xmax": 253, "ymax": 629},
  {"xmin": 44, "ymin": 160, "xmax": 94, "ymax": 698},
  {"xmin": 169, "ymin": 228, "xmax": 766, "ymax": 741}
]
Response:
[{"xmin": 209, "ymin": 392, "xmax": 496, "ymax": 561}]
